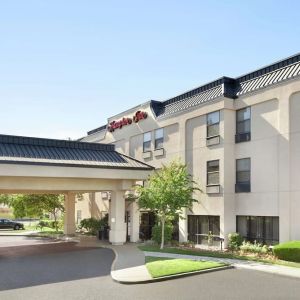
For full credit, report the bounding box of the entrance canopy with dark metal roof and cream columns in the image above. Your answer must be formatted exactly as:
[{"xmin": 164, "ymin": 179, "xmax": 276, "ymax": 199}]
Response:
[{"xmin": 0, "ymin": 135, "xmax": 153, "ymax": 244}]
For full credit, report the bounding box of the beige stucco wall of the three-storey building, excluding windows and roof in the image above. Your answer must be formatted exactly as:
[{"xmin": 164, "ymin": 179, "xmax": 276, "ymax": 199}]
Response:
[{"xmin": 81, "ymin": 80, "xmax": 300, "ymax": 241}]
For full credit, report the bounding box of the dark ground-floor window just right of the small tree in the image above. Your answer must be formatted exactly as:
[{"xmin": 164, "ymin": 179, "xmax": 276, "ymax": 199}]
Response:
[{"xmin": 188, "ymin": 215, "xmax": 220, "ymax": 245}]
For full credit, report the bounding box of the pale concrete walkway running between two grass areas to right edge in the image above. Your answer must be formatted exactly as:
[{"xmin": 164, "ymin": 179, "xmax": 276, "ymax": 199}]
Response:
[{"xmin": 144, "ymin": 252, "xmax": 300, "ymax": 279}]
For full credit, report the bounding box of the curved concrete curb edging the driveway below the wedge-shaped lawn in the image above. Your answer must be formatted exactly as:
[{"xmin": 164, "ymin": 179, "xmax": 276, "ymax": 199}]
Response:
[{"xmin": 111, "ymin": 265, "xmax": 235, "ymax": 285}]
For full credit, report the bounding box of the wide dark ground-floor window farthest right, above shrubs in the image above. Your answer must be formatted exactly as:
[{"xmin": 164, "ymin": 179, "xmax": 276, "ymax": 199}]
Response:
[{"xmin": 236, "ymin": 216, "xmax": 279, "ymax": 245}]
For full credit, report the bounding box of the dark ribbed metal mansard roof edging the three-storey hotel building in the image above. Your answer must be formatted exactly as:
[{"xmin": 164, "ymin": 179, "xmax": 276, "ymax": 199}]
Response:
[{"xmin": 88, "ymin": 53, "xmax": 300, "ymax": 135}]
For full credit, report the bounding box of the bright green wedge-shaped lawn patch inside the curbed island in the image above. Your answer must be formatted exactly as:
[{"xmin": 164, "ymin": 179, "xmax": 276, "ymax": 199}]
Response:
[{"xmin": 145, "ymin": 256, "xmax": 225, "ymax": 278}]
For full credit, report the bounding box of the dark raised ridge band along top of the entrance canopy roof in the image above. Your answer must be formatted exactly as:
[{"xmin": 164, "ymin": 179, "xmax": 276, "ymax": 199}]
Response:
[{"xmin": 0, "ymin": 134, "xmax": 115, "ymax": 151}]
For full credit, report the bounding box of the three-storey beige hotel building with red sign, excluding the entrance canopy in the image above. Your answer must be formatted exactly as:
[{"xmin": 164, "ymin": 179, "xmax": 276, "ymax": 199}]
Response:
[{"xmin": 76, "ymin": 54, "xmax": 300, "ymax": 244}]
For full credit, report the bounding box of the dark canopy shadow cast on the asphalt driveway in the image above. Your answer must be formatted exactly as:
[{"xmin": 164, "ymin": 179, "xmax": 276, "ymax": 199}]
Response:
[{"xmin": 0, "ymin": 243, "xmax": 114, "ymax": 291}]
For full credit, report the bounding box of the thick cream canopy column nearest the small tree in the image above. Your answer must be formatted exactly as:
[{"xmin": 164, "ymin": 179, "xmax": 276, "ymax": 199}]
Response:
[{"xmin": 109, "ymin": 191, "xmax": 126, "ymax": 245}]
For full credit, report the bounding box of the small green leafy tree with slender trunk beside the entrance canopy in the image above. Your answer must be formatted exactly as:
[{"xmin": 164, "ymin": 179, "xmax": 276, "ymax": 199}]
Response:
[{"xmin": 135, "ymin": 161, "xmax": 200, "ymax": 249}]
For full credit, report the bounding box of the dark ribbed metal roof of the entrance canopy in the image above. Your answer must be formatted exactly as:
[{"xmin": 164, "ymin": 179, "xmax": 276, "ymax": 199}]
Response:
[{"xmin": 0, "ymin": 135, "xmax": 153, "ymax": 170}]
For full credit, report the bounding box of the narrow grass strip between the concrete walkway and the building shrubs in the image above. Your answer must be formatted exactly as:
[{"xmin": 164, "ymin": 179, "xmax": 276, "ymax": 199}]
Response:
[{"xmin": 139, "ymin": 246, "xmax": 300, "ymax": 268}]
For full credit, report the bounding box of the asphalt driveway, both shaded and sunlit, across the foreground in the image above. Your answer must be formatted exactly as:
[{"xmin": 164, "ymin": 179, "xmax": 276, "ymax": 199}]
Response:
[{"xmin": 0, "ymin": 237, "xmax": 300, "ymax": 300}]
